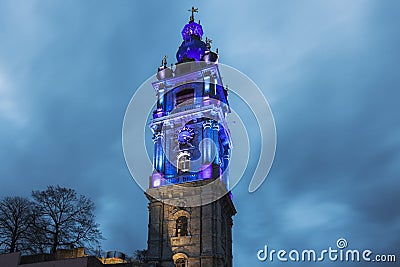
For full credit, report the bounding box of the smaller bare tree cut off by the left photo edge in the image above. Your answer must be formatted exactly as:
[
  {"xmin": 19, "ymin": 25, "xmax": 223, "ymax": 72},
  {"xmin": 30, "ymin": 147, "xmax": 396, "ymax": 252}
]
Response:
[{"xmin": 0, "ymin": 197, "xmax": 33, "ymax": 253}]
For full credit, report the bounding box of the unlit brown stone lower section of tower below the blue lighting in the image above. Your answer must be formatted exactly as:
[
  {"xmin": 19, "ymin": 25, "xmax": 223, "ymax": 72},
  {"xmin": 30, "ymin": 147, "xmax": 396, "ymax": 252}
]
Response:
[{"xmin": 146, "ymin": 186, "xmax": 236, "ymax": 267}]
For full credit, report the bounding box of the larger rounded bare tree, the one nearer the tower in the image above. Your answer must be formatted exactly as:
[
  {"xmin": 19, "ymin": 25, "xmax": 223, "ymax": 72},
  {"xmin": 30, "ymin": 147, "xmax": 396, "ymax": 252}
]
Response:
[{"xmin": 32, "ymin": 186, "xmax": 102, "ymax": 253}]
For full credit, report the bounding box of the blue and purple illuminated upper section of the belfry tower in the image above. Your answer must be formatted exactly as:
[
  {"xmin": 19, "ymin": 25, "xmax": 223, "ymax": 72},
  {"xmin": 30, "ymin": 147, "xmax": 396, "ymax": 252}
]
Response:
[{"xmin": 150, "ymin": 7, "xmax": 232, "ymax": 188}]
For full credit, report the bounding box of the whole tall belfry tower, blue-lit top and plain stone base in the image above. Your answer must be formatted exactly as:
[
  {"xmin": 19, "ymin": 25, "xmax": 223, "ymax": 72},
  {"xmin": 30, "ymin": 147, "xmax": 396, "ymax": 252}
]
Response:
[{"xmin": 146, "ymin": 8, "xmax": 236, "ymax": 267}]
